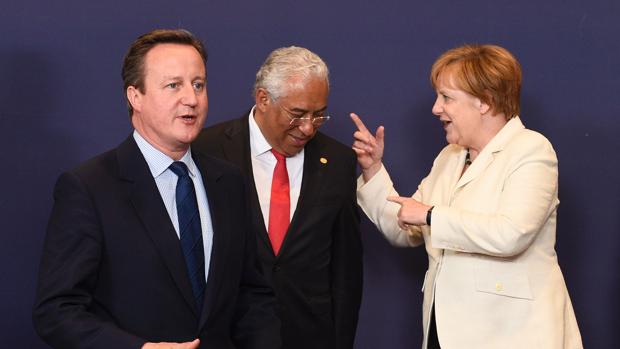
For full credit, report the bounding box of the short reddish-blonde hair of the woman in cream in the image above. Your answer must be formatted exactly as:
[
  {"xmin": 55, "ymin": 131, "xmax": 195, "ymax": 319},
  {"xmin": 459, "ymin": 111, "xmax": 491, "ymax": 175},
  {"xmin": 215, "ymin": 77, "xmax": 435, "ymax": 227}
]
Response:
[{"xmin": 430, "ymin": 45, "xmax": 521, "ymax": 119}]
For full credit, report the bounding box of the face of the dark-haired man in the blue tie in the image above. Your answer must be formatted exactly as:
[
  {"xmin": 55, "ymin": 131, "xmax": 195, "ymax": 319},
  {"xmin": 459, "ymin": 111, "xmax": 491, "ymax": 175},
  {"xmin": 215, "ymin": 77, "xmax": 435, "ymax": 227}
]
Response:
[{"xmin": 127, "ymin": 44, "xmax": 209, "ymax": 159}]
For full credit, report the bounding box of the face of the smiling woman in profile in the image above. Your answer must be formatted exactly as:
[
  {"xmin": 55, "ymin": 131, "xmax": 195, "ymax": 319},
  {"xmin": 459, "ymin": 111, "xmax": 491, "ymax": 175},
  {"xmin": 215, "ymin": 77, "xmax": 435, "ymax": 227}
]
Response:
[{"xmin": 433, "ymin": 69, "xmax": 482, "ymax": 148}]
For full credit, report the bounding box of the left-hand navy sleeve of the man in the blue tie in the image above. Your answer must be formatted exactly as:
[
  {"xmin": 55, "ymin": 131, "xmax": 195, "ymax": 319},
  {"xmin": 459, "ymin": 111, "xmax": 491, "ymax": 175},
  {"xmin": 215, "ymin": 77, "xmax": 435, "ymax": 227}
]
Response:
[{"xmin": 33, "ymin": 173, "xmax": 145, "ymax": 349}]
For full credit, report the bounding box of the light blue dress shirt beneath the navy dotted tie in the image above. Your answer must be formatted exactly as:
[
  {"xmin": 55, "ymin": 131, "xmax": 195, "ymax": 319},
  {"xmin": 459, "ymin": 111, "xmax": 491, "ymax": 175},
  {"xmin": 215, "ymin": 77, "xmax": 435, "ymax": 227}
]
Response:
[{"xmin": 133, "ymin": 130, "xmax": 213, "ymax": 280}]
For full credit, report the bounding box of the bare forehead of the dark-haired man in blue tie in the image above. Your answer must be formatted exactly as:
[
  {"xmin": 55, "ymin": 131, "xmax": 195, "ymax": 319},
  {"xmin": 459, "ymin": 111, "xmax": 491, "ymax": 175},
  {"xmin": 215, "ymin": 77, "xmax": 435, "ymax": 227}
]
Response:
[{"xmin": 144, "ymin": 43, "xmax": 205, "ymax": 75}]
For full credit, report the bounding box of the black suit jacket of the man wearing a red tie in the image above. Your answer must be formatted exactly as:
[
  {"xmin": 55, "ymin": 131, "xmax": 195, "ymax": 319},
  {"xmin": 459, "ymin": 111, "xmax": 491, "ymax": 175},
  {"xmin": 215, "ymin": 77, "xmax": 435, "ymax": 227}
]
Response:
[{"xmin": 192, "ymin": 116, "xmax": 362, "ymax": 349}]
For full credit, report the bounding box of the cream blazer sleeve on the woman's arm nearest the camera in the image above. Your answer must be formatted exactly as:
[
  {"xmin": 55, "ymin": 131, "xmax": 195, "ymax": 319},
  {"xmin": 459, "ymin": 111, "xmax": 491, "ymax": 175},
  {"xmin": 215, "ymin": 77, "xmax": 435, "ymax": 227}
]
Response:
[{"xmin": 431, "ymin": 134, "xmax": 559, "ymax": 257}]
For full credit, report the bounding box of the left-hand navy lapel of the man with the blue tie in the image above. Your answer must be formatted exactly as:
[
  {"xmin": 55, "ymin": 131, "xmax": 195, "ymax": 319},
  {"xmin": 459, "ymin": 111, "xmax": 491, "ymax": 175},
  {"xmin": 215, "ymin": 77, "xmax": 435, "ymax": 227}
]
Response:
[{"xmin": 117, "ymin": 136, "xmax": 198, "ymax": 317}]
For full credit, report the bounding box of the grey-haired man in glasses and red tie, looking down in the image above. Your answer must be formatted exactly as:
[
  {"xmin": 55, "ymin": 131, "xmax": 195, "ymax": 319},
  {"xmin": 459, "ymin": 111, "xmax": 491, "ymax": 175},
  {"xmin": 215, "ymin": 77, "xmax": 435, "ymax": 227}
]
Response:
[{"xmin": 192, "ymin": 47, "xmax": 362, "ymax": 349}]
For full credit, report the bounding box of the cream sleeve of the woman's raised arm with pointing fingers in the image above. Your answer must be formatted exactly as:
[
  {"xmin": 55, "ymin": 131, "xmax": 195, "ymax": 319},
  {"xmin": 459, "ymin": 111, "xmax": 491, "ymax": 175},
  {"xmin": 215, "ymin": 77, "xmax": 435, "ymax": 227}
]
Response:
[{"xmin": 357, "ymin": 165, "xmax": 426, "ymax": 247}]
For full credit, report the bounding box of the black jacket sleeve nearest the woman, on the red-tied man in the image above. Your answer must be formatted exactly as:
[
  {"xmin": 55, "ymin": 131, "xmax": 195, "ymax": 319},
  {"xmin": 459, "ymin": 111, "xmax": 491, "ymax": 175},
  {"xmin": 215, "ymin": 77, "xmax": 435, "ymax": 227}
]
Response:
[{"xmin": 331, "ymin": 154, "xmax": 363, "ymax": 349}]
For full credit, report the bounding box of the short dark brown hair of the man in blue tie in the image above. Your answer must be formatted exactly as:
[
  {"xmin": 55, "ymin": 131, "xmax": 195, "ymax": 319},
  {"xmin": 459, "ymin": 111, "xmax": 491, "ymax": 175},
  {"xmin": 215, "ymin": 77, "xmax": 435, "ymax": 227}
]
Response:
[{"xmin": 121, "ymin": 29, "xmax": 207, "ymax": 117}]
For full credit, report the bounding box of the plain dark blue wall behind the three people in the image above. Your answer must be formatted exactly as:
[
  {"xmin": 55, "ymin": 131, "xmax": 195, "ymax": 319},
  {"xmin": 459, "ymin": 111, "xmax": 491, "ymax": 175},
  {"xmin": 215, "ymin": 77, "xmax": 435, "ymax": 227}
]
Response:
[{"xmin": 0, "ymin": 0, "xmax": 620, "ymax": 348}]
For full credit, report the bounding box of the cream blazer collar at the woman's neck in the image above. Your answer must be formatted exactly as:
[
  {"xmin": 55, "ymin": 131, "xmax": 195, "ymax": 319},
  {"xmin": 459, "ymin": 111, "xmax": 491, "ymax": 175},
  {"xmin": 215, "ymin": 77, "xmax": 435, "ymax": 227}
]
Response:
[{"xmin": 456, "ymin": 116, "xmax": 525, "ymax": 189}]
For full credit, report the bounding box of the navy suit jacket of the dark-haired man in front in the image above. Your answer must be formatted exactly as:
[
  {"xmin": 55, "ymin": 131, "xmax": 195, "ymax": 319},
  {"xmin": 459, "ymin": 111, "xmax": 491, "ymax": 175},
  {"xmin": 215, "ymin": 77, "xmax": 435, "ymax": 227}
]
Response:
[{"xmin": 33, "ymin": 136, "xmax": 280, "ymax": 349}]
